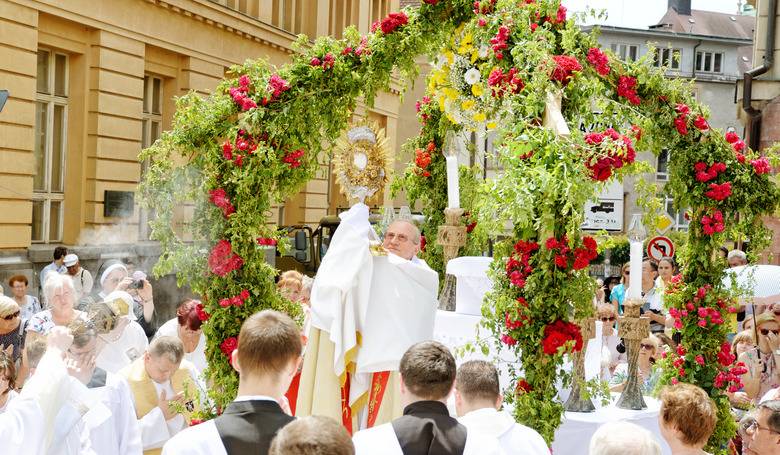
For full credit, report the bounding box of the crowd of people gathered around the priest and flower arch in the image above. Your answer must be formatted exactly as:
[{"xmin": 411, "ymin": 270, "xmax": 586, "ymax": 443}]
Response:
[{"xmin": 0, "ymin": 239, "xmax": 780, "ymax": 455}]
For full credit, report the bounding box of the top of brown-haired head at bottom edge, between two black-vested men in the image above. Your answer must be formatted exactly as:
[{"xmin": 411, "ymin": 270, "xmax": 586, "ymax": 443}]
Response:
[{"xmin": 268, "ymin": 416, "xmax": 355, "ymax": 455}]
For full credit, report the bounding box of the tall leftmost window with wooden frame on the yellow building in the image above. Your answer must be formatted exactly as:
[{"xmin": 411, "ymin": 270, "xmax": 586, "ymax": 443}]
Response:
[{"xmin": 31, "ymin": 49, "xmax": 68, "ymax": 243}]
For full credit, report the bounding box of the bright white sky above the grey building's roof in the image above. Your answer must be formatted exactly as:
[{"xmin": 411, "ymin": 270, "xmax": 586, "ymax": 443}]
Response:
[{"xmin": 563, "ymin": 0, "xmax": 738, "ymax": 29}]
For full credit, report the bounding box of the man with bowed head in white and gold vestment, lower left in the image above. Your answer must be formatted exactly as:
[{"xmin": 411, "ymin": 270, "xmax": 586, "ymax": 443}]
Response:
[{"xmin": 119, "ymin": 337, "xmax": 198, "ymax": 455}]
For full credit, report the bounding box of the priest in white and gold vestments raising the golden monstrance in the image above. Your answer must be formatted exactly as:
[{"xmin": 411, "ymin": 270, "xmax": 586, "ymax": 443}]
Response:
[{"xmin": 296, "ymin": 203, "xmax": 439, "ymax": 432}]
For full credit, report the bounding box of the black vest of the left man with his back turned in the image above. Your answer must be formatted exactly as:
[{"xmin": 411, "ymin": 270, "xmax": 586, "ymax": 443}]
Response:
[{"xmin": 214, "ymin": 400, "xmax": 295, "ymax": 455}]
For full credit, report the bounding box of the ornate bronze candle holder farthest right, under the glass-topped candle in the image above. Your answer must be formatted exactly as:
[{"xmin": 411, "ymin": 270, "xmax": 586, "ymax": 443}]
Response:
[{"xmin": 617, "ymin": 298, "xmax": 650, "ymax": 411}]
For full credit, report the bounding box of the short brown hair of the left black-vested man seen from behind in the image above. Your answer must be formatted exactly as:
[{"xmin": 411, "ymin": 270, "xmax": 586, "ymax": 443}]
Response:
[{"xmin": 238, "ymin": 310, "xmax": 303, "ymax": 374}]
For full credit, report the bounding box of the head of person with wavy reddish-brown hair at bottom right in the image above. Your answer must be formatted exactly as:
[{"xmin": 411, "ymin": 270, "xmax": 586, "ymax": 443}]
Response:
[{"xmin": 658, "ymin": 383, "xmax": 718, "ymax": 455}]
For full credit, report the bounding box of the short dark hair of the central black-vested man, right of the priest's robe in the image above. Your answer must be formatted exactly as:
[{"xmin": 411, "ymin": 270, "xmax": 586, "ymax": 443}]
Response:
[{"xmin": 399, "ymin": 341, "xmax": 457, "ymax": 400}]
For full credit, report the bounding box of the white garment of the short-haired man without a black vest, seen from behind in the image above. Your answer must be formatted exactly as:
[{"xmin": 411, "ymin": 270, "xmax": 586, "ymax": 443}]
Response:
[{"xmin": 458, "ymin": 408, "xmax": 550, "ymax": 455}]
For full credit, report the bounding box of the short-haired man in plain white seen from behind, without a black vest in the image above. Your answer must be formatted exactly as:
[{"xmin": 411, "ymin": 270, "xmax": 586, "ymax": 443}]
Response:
[{"xmin": 455, "ymin": 362, "xmax": 544, "ymax": 455}]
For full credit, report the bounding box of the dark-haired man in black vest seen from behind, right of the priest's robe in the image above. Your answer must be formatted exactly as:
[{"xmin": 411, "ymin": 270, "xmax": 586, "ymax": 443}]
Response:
[{"xmin": 352, "ymin": 341, "xmax": 503, "ymax": 455}]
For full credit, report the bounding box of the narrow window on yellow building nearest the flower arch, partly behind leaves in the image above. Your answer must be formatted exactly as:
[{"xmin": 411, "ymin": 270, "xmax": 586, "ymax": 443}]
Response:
[{"xmin": 138, "ymin": 74, "xmax": 163, "ymax": 240}]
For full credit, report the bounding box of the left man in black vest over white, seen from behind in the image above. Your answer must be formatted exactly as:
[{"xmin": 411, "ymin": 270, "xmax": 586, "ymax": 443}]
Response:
[{"xmin": 163, "ymin": 310, "xmax": 302, "ymax": 455}]
